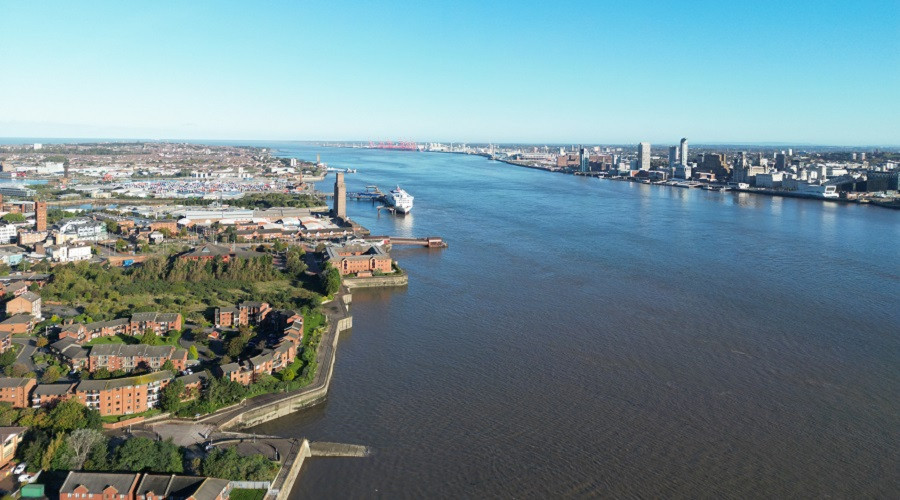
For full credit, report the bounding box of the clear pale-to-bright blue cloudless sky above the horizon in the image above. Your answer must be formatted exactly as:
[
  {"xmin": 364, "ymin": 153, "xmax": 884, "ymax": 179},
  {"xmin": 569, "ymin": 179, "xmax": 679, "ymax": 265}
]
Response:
[{"xmin": 0, "ymin": 0, "xmax": 900, "ymax": 145}]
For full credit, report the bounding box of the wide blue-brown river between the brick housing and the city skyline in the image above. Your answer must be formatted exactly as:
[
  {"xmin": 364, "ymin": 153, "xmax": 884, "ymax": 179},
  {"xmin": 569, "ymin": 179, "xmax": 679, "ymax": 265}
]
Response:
[{"xmin": 248, "ymin": 144, "xmax": 900, "ymax": 498}]
